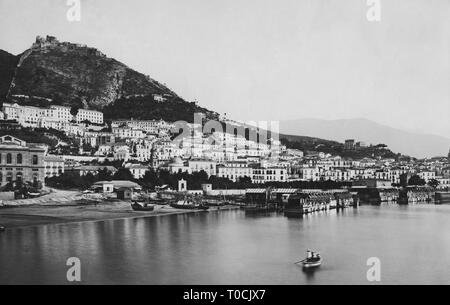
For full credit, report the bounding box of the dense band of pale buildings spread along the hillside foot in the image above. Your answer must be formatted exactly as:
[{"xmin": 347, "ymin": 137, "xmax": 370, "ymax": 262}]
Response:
[{"xmin": 0, "ymin": 97, "xmax": 450, "ymax": 200}]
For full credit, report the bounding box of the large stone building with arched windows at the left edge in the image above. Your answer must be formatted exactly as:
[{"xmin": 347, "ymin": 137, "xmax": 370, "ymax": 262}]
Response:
[{"xmin": 0, "ymin": 135, "xmax": 47, "ymax": 185}]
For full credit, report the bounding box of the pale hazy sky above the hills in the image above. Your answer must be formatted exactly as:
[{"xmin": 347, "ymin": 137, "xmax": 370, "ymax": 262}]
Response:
[{"xmin": 0, "ymin": 0, "xmax": 450, "ymax": 136}]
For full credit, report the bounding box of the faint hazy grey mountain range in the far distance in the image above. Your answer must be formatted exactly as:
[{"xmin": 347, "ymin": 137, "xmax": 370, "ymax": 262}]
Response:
[{"xmin": 280, "ymin": 119, "xmax": 450, "ymax": 158}]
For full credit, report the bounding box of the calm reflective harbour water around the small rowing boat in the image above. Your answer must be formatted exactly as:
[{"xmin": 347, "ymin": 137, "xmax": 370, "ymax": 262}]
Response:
[{"xmin": 0, "ymin": 205, "xmax": 450, "ymax": 284}]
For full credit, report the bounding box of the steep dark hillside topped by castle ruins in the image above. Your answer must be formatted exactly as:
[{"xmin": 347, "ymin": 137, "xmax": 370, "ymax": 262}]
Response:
[{"xmin": 0, "ymin": 36, "xmax": 216, "ymax": 120}]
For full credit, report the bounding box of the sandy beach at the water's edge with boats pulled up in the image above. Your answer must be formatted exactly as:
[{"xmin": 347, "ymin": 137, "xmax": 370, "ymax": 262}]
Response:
[{"xmin": 0, "ymin": 201, "xmax": 243, "ymax": 229}]
